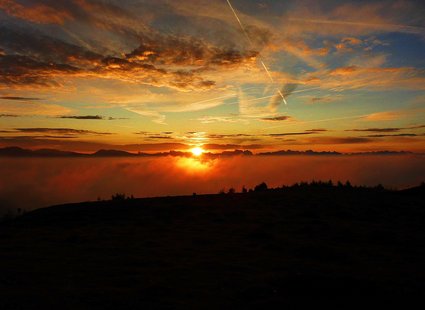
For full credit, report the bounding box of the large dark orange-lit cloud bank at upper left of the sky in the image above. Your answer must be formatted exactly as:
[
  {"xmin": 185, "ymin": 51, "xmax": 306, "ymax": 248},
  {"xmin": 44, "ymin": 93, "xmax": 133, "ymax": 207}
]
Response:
[{"xmin": 0, "ymin": 20, "xmax": 258, "ymax": 91}]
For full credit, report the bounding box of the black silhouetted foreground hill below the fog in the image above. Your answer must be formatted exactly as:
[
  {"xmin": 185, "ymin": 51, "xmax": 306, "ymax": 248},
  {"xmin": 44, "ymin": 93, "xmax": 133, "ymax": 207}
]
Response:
[{"xmin": 0, "ymin": 187, "xmax": 425, "ymax": 309}]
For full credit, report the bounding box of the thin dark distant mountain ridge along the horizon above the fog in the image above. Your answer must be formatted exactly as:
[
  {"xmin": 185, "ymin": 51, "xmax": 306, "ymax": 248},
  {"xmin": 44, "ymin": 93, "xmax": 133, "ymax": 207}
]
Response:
[{"xmin": 0, "ymin": 146, "xmax": 416, "ymax": 158}]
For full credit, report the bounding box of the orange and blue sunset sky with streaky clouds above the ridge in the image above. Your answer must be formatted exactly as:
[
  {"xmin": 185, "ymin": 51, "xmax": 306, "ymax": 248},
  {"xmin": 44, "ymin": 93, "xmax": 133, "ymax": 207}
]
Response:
[{"xmin": 0, "ymin": 0, "xmax": 425, "ymax": 152}]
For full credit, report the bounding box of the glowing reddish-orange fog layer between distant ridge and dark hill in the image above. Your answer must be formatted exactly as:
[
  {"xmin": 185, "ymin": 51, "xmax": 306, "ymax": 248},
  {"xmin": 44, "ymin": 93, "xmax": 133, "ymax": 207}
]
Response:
[{"xmin": 0, "ymin": 155, "xmax": 425, "ymax": 213}]
